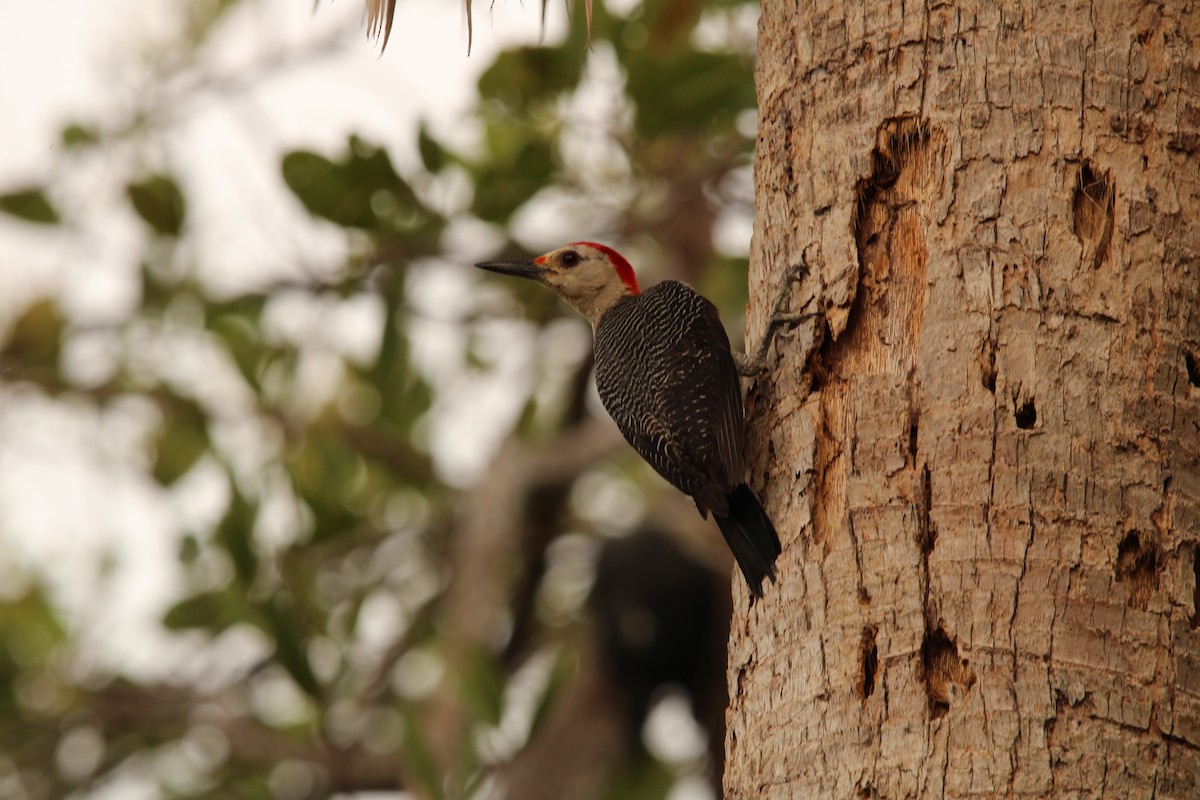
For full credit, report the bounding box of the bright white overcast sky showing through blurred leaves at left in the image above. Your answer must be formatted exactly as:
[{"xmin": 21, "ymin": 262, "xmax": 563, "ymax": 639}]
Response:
[{"xmin": 0, "ymin": 0, "xmax": 565, "ymax": 673}]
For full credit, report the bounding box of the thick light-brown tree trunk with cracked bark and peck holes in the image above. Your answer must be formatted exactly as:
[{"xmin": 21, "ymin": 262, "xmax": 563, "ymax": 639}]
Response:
[{"xmin": 725, "ymin": 0, "xmax": 1200, "ymax": 800}]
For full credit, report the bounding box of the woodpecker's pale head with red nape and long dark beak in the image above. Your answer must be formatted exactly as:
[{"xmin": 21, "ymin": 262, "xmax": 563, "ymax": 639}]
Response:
[{"xmin": 475, "ymin": 241, "xmax": 641, "ymax": 327}]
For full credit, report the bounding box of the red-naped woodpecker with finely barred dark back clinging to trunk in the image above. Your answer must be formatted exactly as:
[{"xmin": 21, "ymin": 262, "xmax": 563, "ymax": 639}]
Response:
[{"xmin": 475, "ymin": 241, "xmax": 786, "ymax": 597}]
